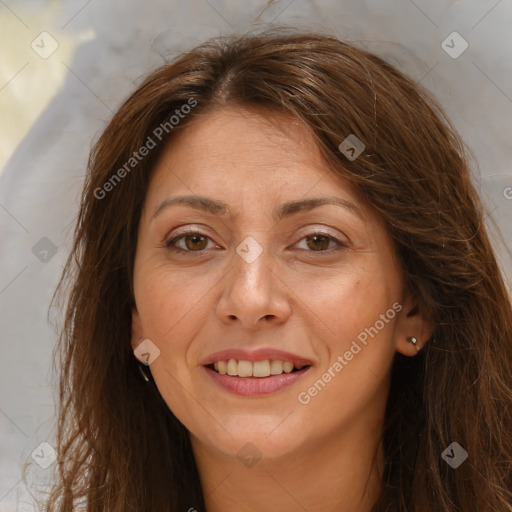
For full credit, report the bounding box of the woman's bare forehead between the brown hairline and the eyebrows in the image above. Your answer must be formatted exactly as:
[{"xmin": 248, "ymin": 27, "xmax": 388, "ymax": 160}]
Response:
[{"xmin": 145, "ymin": 108, "xmax": 356, "ymax": 202}]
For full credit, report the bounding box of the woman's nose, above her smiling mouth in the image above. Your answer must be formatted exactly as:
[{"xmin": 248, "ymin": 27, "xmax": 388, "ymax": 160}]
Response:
[{"xmin": 216, "ymin": 245, "xmax": 291, "ymax": 329}]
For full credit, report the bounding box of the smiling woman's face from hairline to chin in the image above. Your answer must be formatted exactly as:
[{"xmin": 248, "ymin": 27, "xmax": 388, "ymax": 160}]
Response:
[{"xmin": 132, "ymin": 109, "xmax": 427, "ymax": 458}]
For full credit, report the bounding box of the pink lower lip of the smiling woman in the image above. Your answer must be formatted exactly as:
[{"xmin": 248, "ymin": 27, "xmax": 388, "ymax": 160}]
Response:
[{"xmin": 204, "ymin": 366, "xmax": 311, "ymax": 396}]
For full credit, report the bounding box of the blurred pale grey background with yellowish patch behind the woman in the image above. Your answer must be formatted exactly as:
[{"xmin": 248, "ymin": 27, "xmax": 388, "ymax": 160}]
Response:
[{"xmin": 0, "ymin": 0, "xmax": 512, "ymax": 512}]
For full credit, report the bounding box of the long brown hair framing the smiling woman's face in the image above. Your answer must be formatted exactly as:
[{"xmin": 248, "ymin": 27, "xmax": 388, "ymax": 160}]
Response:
[{"xmin": 41, "ymin": 32, "xmax": 512, "ymax": 512}]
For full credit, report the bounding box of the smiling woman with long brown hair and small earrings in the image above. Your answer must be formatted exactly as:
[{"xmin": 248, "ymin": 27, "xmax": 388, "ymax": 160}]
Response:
[{"xmin": 47, "ymin": 33, "xmax": 512, "ymax": 512}]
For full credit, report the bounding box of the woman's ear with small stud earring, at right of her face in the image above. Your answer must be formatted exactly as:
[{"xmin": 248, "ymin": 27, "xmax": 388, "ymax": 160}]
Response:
[{"xmin": 395, "ymin": 293, "xmax": 434, "ymax": 357}]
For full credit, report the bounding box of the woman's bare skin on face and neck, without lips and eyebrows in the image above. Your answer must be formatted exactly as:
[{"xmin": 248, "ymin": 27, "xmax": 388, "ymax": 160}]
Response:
[{"xmin": 132, "ymin": 108, "xmax": 431, "ymax": 512}]
